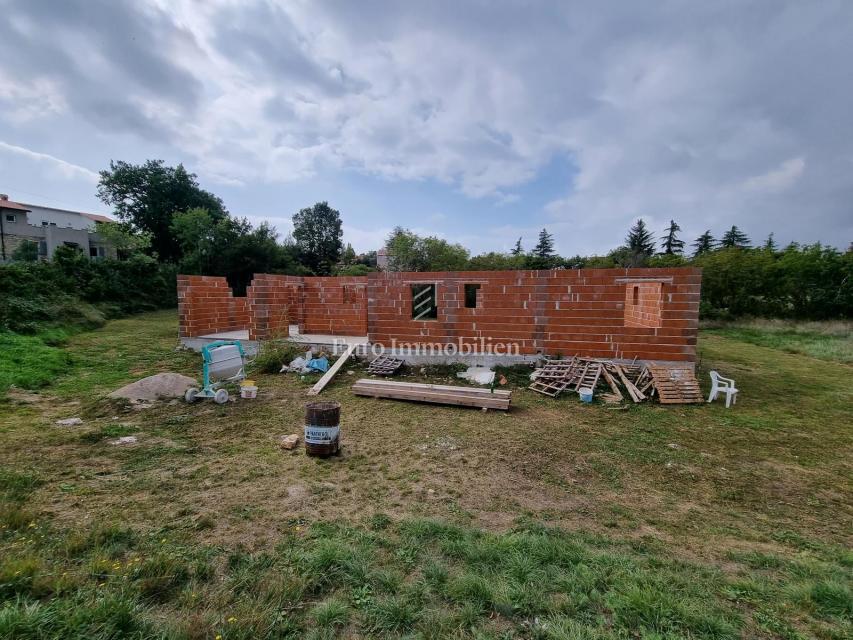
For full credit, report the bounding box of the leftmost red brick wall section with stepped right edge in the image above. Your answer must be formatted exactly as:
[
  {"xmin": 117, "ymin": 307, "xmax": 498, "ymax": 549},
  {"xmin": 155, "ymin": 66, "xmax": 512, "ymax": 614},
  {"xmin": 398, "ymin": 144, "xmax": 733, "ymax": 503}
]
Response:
[{"xmin": 178, "ymin": 275, "xmax": 249, "ymax": 338}]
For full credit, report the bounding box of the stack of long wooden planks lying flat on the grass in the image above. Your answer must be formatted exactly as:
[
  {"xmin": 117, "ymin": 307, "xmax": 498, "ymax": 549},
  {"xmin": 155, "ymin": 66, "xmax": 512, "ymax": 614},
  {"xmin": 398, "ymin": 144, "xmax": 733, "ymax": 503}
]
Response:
[{"xmin": 352, "ymin": 378, "xmax": 512, "ymax": 411}]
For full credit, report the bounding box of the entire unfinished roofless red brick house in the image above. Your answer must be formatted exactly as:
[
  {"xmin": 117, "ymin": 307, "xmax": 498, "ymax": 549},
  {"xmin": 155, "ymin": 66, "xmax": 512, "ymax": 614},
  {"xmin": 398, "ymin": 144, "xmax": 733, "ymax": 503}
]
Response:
[{"xmin": 178, "ymin": 268, "xmax": 702, "ymax": 362}]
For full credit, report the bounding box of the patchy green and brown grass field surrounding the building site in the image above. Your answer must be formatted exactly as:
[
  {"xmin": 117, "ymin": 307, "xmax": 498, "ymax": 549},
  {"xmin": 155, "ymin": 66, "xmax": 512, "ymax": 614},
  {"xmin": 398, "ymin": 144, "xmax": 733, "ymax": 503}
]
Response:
[{"xmin": 0, "ymin": 312, "xmax": 853, "ymax": 640}]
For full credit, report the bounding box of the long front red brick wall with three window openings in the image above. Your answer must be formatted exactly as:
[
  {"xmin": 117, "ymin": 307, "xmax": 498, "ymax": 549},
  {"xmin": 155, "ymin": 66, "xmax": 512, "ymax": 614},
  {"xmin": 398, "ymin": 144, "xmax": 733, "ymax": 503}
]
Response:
[{"xmin": 368, "ymin": 268, "xmax": 701, "ymax": 361}]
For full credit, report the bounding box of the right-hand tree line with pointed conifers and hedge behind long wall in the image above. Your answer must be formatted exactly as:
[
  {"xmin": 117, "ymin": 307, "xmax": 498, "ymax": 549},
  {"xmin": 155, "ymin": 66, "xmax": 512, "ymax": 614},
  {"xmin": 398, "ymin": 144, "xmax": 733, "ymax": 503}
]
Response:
[{"xmin": 386, "ymin": 218, "xmax": 853, "ymax": 320}]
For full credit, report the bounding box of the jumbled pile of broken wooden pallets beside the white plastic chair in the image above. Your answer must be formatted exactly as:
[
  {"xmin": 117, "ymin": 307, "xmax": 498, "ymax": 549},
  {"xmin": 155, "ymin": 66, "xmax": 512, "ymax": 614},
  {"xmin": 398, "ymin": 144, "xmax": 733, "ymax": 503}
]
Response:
[{"xmin": 528, "ymin": 356, "xmax": 702, "ymax": 404}]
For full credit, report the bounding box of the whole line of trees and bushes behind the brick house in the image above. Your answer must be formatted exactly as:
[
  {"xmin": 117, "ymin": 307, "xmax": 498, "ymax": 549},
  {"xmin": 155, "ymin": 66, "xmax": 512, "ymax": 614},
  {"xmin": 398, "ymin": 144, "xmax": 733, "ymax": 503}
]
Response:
[{"xmin": 6, "ymin": 160, "xmax": 853, "ymax": 319}]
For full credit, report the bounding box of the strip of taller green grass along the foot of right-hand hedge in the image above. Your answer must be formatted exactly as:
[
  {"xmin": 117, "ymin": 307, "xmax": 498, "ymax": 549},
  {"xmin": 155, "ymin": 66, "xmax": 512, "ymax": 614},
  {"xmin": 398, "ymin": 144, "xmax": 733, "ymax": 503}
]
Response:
[{"xmin": 708, "ymin": 320, "xmax": 853, "ymax": 364}]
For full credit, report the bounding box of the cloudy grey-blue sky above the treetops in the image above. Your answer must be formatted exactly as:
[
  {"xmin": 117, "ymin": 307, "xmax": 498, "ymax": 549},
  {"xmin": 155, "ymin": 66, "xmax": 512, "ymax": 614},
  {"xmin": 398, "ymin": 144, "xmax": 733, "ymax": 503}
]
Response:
[{"xmin": 0, "ymin": 0, "xmax": 853, "ymax": 255}]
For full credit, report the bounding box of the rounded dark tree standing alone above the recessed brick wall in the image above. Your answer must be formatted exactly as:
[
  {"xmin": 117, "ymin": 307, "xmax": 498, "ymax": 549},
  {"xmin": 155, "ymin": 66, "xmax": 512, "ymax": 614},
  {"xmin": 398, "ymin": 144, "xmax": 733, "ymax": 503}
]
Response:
[{"xmin": 293, "ymin": 201, "xmax": 344, "ymax": 275}]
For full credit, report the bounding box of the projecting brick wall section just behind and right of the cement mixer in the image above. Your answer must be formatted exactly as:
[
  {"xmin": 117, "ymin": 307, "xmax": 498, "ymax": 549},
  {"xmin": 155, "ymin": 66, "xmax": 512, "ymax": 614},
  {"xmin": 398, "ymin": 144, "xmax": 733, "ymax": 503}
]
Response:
[{"xmin": 246, "ymin": 273, "xmax": 302, "ymax": 340}]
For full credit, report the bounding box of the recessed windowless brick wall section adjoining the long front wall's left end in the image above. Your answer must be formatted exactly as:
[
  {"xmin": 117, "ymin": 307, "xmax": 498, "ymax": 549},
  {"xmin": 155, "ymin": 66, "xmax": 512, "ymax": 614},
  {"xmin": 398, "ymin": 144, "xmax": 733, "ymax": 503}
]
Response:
[{"xmin": 299, "ymin": 276, "xmax": 367, "ymax": 336}]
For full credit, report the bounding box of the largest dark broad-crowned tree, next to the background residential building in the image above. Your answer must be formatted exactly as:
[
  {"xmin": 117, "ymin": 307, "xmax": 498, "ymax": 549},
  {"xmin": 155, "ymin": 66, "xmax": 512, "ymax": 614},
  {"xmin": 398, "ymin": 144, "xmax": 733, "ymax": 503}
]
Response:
[{"xmin": 98, "ymin": 160, "xmax": 228, "ymax": 262}]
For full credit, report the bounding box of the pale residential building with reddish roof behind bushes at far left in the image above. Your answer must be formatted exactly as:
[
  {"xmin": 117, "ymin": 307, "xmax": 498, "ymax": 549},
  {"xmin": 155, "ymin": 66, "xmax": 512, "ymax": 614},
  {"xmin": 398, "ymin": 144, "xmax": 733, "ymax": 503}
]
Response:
[{"xmin": 0, "ymin": 193, "xmax": 116, "ymax": 262}]
